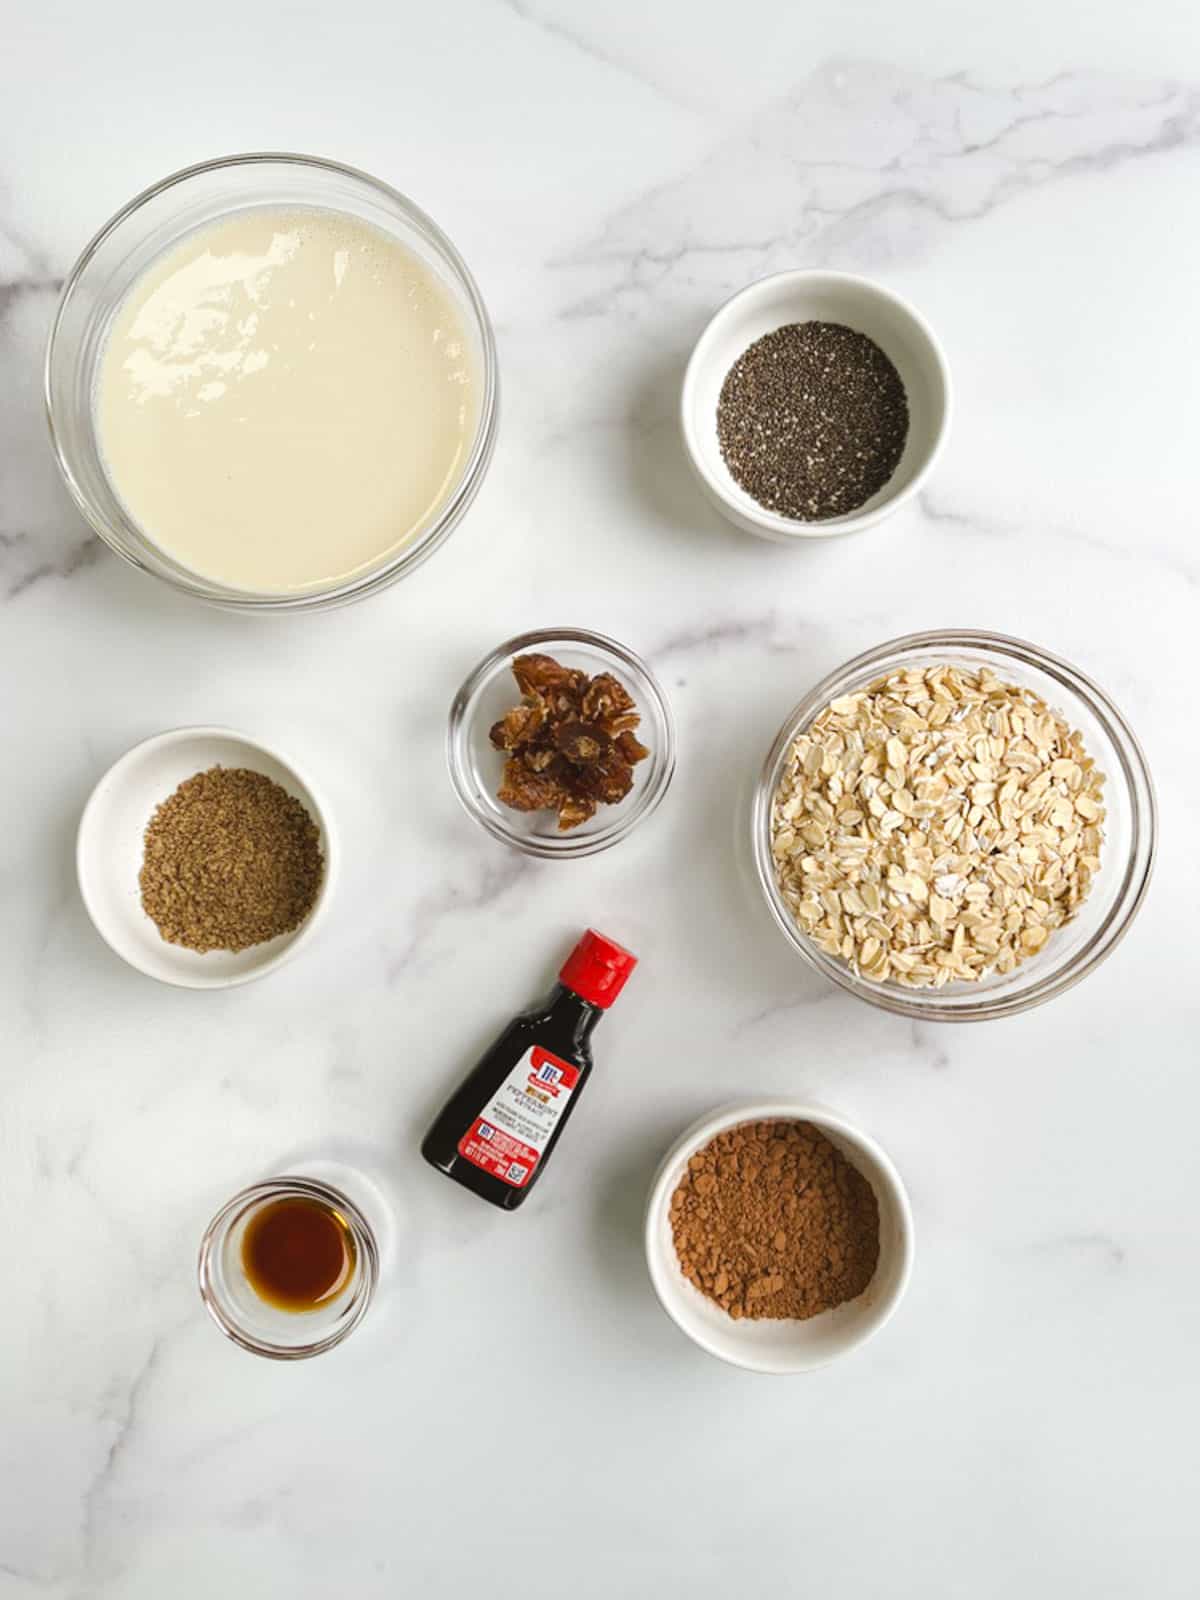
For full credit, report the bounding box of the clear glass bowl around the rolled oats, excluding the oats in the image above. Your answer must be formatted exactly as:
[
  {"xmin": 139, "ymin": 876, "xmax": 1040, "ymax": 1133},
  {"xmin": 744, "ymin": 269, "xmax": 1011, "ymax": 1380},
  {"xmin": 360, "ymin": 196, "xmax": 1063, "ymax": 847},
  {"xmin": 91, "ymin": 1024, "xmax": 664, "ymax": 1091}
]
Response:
[{"xmin": 750, "ymin": 629, "xmax": 1157, "ymax": 1022}]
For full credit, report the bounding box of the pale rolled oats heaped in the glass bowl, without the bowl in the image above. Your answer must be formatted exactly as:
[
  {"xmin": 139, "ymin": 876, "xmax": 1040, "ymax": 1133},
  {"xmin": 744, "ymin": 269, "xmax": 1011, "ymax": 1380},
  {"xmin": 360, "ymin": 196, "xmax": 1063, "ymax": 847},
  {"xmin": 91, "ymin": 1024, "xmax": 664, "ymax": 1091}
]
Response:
[{"xmin": 771, "ymin": 666, "xmax": 1104, "ymax": 989}]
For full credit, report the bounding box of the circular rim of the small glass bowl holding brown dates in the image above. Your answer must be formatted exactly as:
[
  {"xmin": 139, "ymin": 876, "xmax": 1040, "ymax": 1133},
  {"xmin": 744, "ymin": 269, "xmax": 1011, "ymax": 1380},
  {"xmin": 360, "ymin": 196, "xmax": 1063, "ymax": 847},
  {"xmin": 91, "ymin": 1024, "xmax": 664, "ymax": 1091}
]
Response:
[{"xmin": 446, "ymin": 627, "xmax": 677, "ymax": 861}]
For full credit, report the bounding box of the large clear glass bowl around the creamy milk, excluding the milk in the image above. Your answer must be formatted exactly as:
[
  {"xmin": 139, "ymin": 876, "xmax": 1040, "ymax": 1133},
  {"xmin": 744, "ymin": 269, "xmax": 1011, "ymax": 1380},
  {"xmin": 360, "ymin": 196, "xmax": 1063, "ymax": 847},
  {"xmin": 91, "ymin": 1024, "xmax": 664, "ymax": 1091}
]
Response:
[{"xmin": 45, "ymin": 154, "xmax": 498, "ymax": 611}]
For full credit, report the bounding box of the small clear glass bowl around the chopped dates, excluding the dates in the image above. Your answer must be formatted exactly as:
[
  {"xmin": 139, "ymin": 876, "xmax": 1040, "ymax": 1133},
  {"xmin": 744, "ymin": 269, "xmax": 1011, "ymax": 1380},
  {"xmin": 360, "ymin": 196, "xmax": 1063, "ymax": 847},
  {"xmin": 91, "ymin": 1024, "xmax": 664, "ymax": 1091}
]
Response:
[{"xmin": 446, "ymin": 627, "xmax": 675, "ymax": 861}]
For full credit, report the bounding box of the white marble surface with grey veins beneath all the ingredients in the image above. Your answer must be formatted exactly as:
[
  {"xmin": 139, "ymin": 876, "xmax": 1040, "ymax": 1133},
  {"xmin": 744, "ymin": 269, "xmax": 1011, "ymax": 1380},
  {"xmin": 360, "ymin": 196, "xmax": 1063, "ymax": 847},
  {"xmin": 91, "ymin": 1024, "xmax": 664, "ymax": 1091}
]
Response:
[{"xmin": 0, "ymin": 0, "xmax": 1200, "ymax": 1600}]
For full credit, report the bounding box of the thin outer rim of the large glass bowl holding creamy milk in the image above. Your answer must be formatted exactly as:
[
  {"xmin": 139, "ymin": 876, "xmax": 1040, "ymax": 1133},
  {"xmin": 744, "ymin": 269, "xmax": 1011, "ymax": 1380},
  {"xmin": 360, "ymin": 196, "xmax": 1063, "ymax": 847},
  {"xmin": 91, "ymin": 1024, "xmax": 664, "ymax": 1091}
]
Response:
[{"xmin": 42, "ymin": 150, "xmax": 499, "ymax": 613}]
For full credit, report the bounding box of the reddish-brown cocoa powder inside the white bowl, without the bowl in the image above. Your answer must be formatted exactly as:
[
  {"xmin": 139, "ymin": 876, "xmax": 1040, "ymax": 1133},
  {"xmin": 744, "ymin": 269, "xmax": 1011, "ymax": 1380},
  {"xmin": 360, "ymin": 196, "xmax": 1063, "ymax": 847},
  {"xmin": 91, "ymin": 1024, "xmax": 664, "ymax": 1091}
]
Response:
[{"xmin": 670, "ymin": 1122, "xmax": 878, "ymax": 1318}]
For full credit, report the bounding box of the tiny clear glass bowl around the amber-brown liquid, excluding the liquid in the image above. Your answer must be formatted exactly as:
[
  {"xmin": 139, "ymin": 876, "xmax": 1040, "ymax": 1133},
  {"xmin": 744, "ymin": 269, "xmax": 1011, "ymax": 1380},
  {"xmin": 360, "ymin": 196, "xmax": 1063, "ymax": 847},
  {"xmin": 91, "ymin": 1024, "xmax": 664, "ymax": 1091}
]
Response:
[{"xmin": 197, "ymin": 1178, "xmax": 379, "ymax": 1362}]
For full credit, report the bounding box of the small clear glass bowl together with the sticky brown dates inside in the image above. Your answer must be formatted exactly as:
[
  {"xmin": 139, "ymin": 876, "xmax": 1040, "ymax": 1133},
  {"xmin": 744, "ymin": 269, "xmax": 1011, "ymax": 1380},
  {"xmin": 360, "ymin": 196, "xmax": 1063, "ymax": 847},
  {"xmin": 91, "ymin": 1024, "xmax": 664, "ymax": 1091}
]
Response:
[{"xmin": 446, "ymin": 627, "xmax": 675, "ymax": 861}]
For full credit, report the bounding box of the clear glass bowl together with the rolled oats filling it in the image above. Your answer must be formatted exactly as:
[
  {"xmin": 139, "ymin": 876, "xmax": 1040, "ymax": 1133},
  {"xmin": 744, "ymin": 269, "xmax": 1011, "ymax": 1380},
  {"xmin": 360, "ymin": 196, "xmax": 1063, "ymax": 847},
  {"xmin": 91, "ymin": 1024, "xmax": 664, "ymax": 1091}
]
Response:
[{"xmin": 752, "ymin": 629, "xmax": 1157, "ymax": 1022}]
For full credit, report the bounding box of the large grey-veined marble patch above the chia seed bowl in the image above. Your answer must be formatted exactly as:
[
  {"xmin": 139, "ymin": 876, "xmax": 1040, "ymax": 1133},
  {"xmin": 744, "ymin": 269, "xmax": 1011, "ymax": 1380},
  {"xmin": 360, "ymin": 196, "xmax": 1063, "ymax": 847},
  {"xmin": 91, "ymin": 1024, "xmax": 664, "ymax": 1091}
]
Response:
[{"xmin": 560, "ymin": 61, "xmax": 1200, "ymax": 315}]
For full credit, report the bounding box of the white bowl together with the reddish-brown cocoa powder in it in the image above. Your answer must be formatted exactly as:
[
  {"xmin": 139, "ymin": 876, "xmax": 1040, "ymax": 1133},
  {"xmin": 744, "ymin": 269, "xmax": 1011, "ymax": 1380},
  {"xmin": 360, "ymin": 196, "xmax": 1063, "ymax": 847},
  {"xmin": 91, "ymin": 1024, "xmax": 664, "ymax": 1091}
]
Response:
[{"xmin": 645, "ymin": 1101, "xmax": 914, "ymax": 1373}]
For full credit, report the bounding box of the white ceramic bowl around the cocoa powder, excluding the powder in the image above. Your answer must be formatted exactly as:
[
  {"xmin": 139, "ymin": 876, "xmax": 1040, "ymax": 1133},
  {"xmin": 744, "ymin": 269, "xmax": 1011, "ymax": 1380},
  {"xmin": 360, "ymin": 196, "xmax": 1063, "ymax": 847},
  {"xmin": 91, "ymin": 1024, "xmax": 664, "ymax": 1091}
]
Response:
[{"xmin": 646, "ymin": 1101, "xmax": 914, "ymax": 1373}]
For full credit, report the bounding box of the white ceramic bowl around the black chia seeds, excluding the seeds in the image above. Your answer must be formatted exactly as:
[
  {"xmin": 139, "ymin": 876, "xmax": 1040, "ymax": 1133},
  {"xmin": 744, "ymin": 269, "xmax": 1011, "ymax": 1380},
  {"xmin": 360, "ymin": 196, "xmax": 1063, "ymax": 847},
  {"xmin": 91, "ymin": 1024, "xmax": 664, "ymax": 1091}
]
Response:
[{"xmin": 680, "ymin": 272, "xmax": 950, "ymax": 544}]
